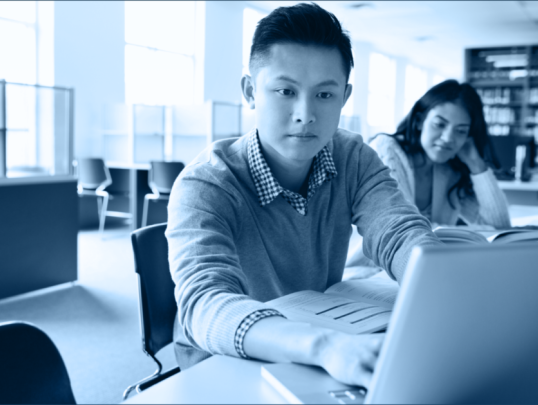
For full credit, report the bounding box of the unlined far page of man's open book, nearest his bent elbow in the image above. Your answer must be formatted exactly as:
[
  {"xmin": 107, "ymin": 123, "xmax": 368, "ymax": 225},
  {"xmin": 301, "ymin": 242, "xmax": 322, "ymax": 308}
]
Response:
[{"xmin": 325, "ymin": 273, "xmax": 399, "ymax": 309}]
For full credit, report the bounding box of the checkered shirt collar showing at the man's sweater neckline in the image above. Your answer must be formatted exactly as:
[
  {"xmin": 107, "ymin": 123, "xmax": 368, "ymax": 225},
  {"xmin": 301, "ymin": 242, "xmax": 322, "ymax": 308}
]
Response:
[{"xmin": 248, "ymin": 129, "xmax": 337, "ymax": 215}]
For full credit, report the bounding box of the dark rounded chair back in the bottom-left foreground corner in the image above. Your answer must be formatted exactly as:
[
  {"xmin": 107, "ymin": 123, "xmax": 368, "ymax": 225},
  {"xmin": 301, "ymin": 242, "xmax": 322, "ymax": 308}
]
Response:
[{"xmin": 0, "ymin": 322, "xmax": 76, "ymax": 404}]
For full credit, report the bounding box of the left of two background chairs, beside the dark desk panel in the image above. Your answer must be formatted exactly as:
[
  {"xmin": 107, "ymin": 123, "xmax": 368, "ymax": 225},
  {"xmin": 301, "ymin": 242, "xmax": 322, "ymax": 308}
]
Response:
[{"xmin": 76, "ymin": 158, "xmax": 131, "ymax": 234}]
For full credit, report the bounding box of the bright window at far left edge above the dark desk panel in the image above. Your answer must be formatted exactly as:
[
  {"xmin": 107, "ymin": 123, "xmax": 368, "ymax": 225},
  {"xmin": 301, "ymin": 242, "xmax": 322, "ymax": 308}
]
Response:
[{"xmin": 0, "ymin": 1, "xmax": 58, "ymax": 177}]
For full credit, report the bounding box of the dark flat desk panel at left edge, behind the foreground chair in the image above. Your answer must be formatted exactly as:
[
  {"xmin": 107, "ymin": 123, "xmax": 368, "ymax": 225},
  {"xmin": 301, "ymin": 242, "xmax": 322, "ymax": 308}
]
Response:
[{"xmin": 0, "ymin": 176, "xmax": 78, "ymax": 299}]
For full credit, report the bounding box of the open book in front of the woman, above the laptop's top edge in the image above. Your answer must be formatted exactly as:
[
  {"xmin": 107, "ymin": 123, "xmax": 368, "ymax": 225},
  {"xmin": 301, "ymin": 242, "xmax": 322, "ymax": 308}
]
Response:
[{"xmin": 433, "ymin": 225, "xmax": 538, "ymax": 244}]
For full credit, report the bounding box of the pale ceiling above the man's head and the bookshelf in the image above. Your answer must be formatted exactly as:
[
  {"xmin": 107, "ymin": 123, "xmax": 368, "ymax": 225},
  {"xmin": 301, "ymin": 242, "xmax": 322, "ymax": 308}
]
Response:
[{"xmin": 244, "ymin": 1, "xmax": 538, "ymax": 78}]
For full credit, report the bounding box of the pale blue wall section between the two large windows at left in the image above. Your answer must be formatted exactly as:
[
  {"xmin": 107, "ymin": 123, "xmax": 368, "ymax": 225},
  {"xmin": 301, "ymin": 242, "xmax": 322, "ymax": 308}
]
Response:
[{"xmin": 54, "ymin": 1, "xmax": 125, "ymax": 157}]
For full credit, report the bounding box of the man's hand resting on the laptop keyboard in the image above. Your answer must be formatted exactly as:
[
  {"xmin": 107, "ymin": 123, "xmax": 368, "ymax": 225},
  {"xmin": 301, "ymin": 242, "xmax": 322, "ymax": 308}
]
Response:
[{"xmin": 320, "ymin": 332, "xmax": 385, "ymax": 388}]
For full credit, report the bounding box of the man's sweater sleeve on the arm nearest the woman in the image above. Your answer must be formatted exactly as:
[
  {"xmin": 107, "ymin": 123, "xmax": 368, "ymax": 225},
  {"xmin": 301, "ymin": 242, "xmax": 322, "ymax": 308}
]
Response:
[{"xmin": 352, "ymin": 144, "xmax": 442, "ymax": 282}]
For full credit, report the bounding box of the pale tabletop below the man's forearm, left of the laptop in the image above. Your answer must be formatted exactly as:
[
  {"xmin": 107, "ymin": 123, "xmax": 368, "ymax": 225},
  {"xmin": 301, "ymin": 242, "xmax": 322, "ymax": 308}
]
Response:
[{"xmin": 123, "ymin": 356, "xmax": 287, "ymax": 404}]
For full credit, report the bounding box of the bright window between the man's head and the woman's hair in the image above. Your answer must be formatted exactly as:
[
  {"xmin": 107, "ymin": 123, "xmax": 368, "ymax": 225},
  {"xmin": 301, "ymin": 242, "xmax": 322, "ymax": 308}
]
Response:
[{"xmin": 367, "ymin": 52, "xmax": 396, "ymax": 130}]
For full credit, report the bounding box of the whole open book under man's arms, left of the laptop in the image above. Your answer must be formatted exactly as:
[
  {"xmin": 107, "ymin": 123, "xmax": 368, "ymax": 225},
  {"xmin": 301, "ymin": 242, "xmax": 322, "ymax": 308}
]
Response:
[{"xmin": 267, "ymin": 275, "xmax": 398, "ymax": 334}]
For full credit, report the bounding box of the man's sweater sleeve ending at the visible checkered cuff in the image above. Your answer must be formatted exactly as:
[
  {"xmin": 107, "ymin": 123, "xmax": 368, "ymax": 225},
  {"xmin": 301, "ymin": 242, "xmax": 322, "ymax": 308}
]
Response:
[{"xmin": 166, "ymin": 168, "xmax": 274, "ymax": 356}]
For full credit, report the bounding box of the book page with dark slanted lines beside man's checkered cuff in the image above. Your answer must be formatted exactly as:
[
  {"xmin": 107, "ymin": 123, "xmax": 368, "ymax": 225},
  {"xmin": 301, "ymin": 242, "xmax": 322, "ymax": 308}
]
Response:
[{"xmin": 266, "ymin": 291, "xmax": 392, "ymax": 334}]
